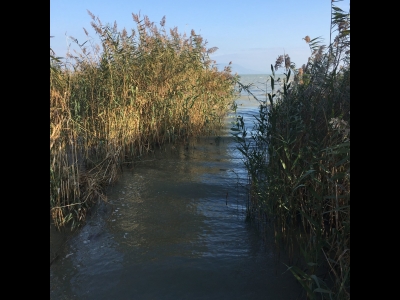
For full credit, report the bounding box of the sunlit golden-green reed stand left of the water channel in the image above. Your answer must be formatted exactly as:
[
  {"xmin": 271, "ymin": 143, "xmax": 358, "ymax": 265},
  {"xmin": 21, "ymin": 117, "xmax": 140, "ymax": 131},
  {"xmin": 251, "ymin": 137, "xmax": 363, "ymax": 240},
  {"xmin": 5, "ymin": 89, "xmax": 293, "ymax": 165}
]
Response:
[{"xmin": 50, "ymin": 12, "xmax": 236, "ymax": 228}]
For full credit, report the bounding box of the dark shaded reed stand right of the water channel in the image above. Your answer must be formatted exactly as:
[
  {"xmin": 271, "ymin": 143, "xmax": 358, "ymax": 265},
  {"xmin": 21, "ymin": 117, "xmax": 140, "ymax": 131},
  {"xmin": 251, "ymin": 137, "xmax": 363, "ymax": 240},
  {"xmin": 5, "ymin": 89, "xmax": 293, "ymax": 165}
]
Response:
[{"xmin": 235, "ymin": 3, "xmax": 350, "ymax": 299}]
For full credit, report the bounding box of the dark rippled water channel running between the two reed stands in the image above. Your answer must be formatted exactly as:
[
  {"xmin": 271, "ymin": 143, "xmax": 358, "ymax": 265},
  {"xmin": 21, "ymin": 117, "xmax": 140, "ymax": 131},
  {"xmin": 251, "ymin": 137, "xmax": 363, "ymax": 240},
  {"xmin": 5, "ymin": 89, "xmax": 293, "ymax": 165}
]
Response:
[{"xmin": 50, "ymin": 74, "xmax": 301, "ymax": 299}]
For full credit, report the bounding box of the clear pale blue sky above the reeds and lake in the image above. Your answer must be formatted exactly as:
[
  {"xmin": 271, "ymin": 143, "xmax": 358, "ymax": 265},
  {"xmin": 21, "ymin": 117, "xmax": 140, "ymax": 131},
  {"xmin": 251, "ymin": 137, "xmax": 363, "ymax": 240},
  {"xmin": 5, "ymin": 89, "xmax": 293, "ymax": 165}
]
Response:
[{"xmin": 50, "ymin": 0, "xmax": 350, "ymax": 74}]
